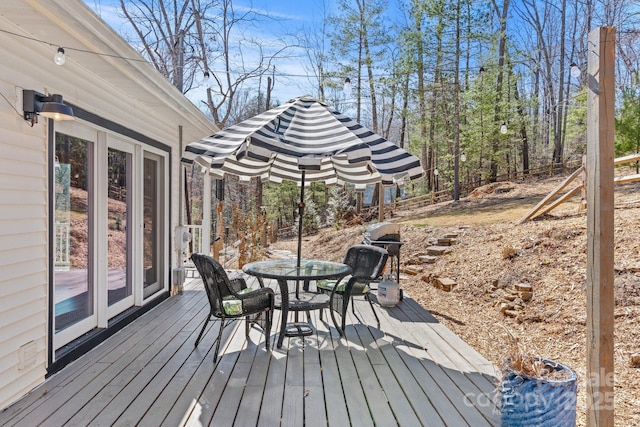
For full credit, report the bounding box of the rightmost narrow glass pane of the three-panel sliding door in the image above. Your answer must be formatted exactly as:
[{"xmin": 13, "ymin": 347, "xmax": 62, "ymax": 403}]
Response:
[{"xmin": 143, "ymin": 153, "xmax": 164, "ymax": 298}]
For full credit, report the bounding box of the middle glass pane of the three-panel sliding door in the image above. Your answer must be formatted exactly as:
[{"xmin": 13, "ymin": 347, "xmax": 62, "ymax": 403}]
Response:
[{"xmin": 107, "ymin": 148, "xmax": 133, "ymax": 306}]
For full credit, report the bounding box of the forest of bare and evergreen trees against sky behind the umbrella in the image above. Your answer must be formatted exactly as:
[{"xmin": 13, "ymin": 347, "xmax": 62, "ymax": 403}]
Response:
[{"xmin": 120, "ymin": 0, "xmax": 640, "ymax": 232}]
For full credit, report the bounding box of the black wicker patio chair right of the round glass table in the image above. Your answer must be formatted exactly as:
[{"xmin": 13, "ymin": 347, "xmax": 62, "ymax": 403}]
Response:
[{"xmin": 317, "ymin": 245, "xmax": 389, "ymax": 336}]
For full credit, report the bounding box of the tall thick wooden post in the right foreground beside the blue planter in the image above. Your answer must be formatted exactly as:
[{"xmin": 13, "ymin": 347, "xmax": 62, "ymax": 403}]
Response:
[{"xmin": 586, "ymin": 27, "xmax": 616, "ymax": 427}]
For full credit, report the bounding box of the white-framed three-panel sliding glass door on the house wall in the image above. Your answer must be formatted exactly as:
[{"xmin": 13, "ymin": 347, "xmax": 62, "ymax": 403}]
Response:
[{"xmin": 50, "ymin": 122, "xmax": 170, "ymax": 349}]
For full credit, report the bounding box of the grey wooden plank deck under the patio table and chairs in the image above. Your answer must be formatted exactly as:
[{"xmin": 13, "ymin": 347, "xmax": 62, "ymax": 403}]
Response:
[{"xmin": 0, "ymin": 279, "xmax": 499, "ymax": 427}]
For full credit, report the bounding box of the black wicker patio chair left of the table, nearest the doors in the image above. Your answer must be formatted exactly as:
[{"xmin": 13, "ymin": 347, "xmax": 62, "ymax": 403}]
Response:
[{"xmin": 191, "ymin": 254, "xmax": 275, "ymax": 363}]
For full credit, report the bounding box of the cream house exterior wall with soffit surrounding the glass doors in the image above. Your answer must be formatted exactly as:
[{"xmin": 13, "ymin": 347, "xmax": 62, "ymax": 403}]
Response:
[{"xmin": 0, "ymin": 0, "xmax": 216, "ymax": 408}]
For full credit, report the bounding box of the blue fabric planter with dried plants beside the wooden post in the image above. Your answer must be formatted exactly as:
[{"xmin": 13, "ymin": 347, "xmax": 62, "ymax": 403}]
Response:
[{"xmin": 500, "ymin": 358, "xmax": 578, "ymax": 427}]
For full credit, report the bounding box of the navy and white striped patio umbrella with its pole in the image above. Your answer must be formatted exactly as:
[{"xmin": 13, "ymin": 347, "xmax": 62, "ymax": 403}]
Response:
[{"xmin": 182, "ymin": 96, "xmax": 423, "ymax": 262}]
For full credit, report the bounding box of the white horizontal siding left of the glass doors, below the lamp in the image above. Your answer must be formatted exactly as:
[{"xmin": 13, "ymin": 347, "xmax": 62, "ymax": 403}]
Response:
[{"xmin": 0, "ymin": 80, "xmax": 48, "ymax": 407}]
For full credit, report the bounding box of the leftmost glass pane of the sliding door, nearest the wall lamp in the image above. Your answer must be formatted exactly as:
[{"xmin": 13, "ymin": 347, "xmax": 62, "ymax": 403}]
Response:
[{"xmin": 53, "ymin": 133, "xmax": 95, "ymax": 333}]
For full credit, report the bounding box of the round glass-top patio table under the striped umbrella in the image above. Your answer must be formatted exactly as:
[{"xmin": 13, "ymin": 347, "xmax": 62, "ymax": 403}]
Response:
[{"xmin": 242, "ymin": 259, "xmax": 351, "ymax": 348}]
